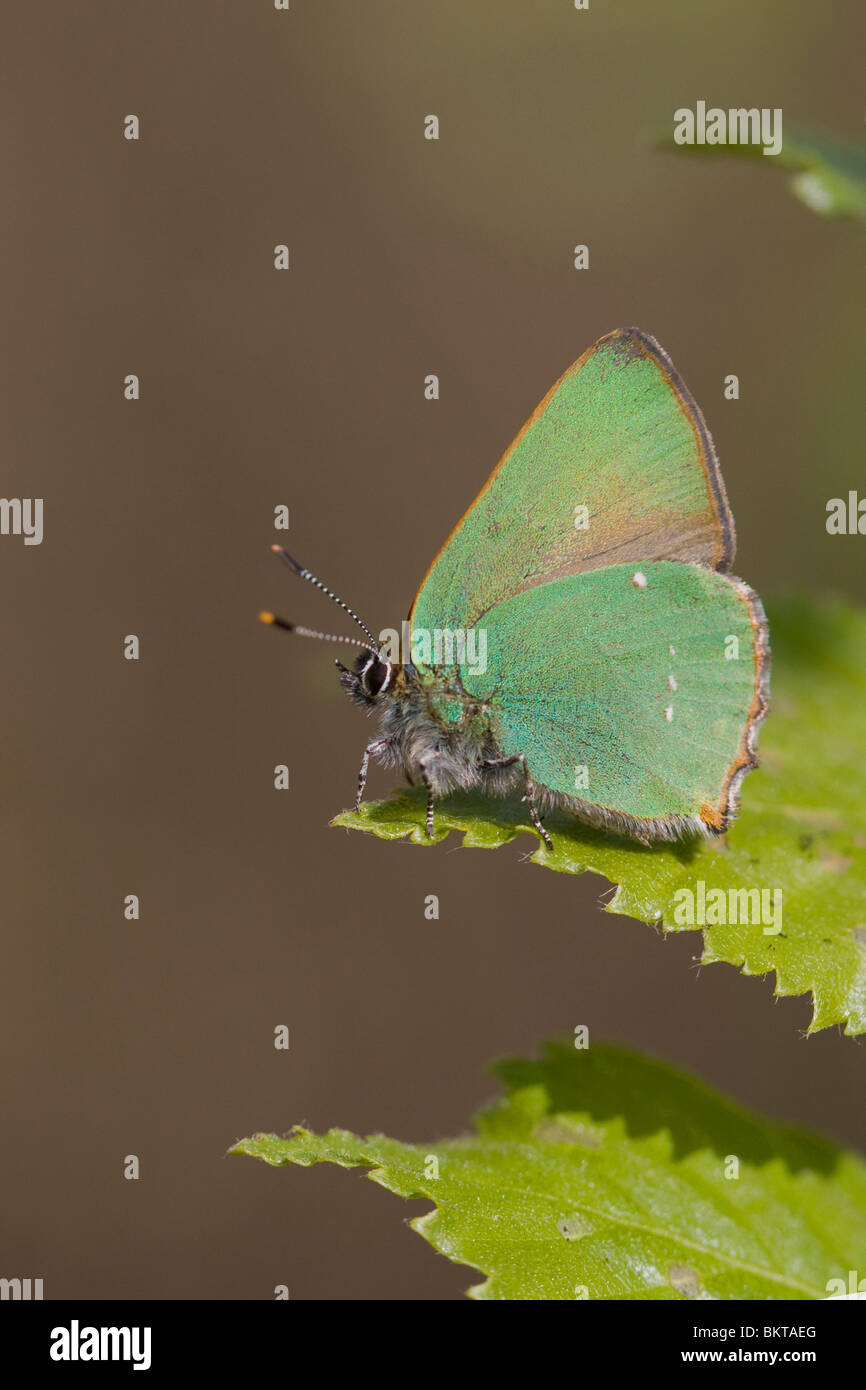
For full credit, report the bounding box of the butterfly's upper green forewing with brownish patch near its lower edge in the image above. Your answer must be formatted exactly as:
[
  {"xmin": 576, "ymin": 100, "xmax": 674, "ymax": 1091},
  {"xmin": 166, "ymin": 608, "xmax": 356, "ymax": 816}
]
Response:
[{"xmin": 410, "ymin": 328, "xmax": 734, "ymax": 630}]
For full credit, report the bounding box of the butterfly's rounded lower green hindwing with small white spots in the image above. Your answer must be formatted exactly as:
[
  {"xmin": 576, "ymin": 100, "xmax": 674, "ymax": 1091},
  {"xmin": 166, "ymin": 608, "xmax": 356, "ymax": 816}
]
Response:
[{"xmin": 460, "ymin": 562, "xmax": 767, "ymax": 834}]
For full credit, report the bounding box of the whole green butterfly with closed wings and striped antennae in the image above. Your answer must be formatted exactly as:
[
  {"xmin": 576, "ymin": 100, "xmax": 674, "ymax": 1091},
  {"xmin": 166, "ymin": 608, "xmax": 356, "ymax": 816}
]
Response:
[{"xmin": 260, "ymin": 328, "xmax": 770, "ymax": 849}]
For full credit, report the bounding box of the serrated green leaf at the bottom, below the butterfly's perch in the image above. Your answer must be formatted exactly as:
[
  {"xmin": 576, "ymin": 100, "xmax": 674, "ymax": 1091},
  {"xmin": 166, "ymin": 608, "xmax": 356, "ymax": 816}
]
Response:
[{"xmin": 231, "ymin": 1043, "xmax": 866, "ymax": 1300}]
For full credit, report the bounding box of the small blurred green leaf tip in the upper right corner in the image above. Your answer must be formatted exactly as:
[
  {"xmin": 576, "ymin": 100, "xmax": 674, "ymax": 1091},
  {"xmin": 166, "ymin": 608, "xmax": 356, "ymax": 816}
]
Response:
[{"xmin": 659, "ymin": 131, "xmax": 866, "ymax": 222}]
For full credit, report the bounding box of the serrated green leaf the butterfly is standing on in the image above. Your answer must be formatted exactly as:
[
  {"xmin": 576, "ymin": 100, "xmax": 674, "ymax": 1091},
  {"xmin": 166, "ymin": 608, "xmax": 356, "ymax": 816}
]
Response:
[{"xmin": 334, "ymin": 599, "xmax": 866, "ymax": 1036}]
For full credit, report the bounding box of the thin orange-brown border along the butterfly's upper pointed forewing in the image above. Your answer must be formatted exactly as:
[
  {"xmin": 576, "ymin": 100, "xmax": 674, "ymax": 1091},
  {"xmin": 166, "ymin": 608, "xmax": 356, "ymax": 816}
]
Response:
[{"xmin": 409, "ymin": 328, "xmax": 737, "ymax": 621}]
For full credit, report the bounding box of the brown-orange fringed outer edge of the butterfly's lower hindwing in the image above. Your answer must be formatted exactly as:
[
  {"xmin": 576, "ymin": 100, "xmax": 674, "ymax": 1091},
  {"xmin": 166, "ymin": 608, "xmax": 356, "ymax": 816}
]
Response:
[{"xmin": 535, "ymin": 574, "xmax": 770, "ymax": 845}]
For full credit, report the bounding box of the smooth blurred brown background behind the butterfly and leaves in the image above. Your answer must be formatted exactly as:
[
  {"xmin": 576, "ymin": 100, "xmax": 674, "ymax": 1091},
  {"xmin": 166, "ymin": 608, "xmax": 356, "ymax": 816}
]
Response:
[{"xmin": 0, "ymin": 0, "xmax": 866, "ymax": 1298}]
